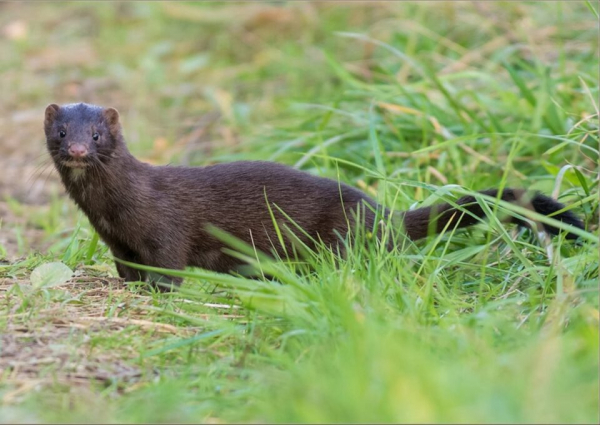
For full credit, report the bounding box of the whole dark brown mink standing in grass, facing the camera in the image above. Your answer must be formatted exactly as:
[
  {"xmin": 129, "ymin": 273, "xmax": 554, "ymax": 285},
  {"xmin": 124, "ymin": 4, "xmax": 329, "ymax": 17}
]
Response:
[{"xmin": 44, "ymin": 103, "xmax": 583, "ymax": 287}]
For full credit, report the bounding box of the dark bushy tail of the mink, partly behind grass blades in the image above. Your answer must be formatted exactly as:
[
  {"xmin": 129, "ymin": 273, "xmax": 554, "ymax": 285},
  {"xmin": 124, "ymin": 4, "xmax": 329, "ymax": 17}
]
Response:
[{"xmin": 403, "ymin": 189, "xmax": 584, "ymax": 240}]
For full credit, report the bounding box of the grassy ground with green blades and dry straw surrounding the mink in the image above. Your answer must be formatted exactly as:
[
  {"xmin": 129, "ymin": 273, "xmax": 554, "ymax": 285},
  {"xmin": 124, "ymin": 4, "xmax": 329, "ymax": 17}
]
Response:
[{"xmin": 0, "ymin": 2, "xmax": 599, "ymax": 423}]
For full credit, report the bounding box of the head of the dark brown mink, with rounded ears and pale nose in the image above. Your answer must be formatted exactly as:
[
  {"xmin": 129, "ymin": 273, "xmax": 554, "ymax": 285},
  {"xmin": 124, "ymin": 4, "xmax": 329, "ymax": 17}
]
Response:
[{"xmin": 44, "ymin": 103, "xmax": 123, "ymax": 169}]
